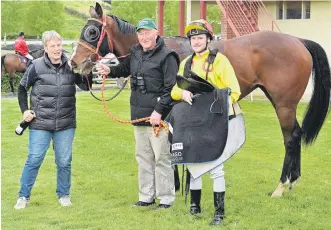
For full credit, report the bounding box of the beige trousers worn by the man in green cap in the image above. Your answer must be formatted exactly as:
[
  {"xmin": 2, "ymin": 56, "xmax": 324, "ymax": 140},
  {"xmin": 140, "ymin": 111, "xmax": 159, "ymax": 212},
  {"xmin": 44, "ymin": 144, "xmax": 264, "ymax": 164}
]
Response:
[{"xmin": 134, "ymin": 126, "xmax": 175, "ymax": 205}]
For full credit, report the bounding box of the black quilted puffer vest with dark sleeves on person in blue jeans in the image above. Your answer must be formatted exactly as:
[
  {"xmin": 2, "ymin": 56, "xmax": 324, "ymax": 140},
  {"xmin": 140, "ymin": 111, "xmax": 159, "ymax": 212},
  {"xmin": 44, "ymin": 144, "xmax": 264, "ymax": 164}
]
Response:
[{"xmin": 19, "ymin": 54, "xmax": 88, "ymax": 131}]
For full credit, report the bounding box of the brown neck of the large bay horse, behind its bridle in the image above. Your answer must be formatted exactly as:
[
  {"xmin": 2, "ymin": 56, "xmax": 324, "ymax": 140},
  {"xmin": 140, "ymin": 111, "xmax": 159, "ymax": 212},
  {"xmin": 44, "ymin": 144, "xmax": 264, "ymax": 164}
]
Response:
[{"xmin": 106, "ymin": 16, "xmax": 138, "ymax": 56}]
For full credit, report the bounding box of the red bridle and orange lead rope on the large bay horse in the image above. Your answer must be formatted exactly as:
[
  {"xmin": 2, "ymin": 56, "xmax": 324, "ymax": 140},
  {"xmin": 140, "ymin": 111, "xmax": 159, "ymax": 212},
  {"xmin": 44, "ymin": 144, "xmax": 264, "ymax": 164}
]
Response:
[{"xmin": 78, "ymin": 16, "xmax": 169, "ymax": 136}]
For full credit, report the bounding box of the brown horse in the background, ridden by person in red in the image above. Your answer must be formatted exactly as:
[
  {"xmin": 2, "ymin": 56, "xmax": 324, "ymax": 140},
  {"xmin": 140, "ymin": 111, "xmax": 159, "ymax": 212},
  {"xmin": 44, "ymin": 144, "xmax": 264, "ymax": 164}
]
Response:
[{"xmin": 1, "ymin": 48, "xmax": 45, "ymax": 93}]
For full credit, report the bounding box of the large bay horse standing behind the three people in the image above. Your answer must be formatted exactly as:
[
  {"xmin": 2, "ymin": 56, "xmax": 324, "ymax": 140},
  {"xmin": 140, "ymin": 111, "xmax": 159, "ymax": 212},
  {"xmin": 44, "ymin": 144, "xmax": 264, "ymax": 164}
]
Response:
[{"xmin": 71, "ymin": 3, "xmax": 331, "ymax": 197}]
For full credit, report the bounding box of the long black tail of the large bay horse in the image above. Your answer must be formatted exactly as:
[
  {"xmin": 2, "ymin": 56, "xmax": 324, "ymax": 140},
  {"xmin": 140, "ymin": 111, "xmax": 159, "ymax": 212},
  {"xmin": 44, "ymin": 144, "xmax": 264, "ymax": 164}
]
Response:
[{"xmin": 301, "ymin": 39, "xmax": 331, "ymax": 145}]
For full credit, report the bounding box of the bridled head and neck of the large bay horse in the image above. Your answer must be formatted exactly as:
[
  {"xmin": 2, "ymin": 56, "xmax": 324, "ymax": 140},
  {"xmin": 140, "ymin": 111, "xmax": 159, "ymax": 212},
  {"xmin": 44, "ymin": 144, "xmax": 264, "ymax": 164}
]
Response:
[{"xmin": 70, "ymin": 3, "xmax": 137, "ymax": 74}]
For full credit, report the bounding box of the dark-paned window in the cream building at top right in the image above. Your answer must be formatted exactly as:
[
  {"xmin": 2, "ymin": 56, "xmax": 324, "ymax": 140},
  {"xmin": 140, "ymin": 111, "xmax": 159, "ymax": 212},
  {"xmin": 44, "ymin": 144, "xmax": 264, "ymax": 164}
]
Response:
[{"xmin": 276, "ymin": 1, "xmax": 310, "ymax": 20}]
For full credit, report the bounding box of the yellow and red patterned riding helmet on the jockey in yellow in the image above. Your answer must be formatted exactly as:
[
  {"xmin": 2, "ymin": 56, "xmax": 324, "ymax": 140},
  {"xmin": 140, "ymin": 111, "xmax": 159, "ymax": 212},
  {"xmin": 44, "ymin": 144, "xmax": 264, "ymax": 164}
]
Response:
[{"xmin": 185, "ymin": 19, "xmax": 214, "ymax": 40}]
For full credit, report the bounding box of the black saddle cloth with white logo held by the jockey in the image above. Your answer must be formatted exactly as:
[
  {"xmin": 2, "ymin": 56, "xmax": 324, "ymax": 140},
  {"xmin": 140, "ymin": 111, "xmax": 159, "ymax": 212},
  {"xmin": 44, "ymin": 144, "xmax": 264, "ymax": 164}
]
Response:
[{"xmin": 166, "ymin": 87, "xmax": 229, "ymax": 164}]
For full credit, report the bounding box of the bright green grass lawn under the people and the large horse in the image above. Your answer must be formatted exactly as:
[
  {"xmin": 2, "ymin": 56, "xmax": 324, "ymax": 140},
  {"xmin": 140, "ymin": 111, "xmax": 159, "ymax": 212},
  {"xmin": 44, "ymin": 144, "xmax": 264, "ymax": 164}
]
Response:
[{"xmin": 1, "ymin": 90, "xmax": 331, "ymax": 230}]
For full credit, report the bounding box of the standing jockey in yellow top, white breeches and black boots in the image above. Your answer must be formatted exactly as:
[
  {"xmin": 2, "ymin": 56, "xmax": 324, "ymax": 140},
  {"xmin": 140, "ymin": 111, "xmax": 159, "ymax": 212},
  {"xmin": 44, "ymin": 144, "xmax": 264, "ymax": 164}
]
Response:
[{"xmin": 171, "ymin": 19, "xmax": 245, "ymax": 225}]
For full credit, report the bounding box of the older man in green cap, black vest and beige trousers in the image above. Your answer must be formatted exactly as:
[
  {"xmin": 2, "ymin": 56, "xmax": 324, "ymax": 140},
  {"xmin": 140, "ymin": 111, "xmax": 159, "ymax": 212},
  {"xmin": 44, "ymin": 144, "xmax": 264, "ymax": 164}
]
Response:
[{"xmin": 96, "ymin": 18, "xmax": 179, "ymax": 209}]
